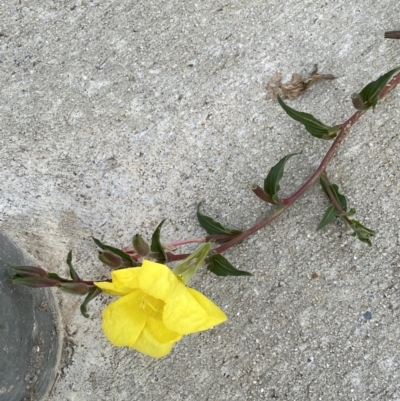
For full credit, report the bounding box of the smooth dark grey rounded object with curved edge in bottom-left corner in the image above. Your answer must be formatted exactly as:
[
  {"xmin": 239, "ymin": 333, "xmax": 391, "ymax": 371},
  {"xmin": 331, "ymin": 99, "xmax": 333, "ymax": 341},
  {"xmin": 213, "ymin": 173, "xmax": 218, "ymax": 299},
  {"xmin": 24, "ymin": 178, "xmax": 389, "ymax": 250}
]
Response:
[{"xmin": 0, "ymin": 233, "xmax": 63, "ymax": 401}]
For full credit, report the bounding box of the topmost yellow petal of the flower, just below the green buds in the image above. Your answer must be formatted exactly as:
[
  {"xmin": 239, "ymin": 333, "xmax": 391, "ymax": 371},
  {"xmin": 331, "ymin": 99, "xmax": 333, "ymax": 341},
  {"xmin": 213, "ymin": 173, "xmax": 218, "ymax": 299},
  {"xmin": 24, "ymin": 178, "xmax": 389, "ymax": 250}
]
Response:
[{"xmin": 138, "ymin": 260, "xmax": 180, "ymax": 302}]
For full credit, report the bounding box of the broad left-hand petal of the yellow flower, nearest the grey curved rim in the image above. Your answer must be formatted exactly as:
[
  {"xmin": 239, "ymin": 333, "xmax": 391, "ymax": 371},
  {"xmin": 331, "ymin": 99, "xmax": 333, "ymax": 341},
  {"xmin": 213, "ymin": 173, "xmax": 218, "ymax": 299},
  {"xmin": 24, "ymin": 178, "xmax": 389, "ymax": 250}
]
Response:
[{"xmin": 103, "ymin": 290, "xmax": 147, "ymax": 347}]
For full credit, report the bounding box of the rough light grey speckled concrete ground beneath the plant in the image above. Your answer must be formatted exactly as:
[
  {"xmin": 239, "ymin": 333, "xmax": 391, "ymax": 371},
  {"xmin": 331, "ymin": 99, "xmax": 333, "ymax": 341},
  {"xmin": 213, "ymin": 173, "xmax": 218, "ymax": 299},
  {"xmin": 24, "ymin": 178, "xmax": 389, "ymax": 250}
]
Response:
[{"xmin": 0, "ymin": 0, "xmax": 400, "ymax": 401}]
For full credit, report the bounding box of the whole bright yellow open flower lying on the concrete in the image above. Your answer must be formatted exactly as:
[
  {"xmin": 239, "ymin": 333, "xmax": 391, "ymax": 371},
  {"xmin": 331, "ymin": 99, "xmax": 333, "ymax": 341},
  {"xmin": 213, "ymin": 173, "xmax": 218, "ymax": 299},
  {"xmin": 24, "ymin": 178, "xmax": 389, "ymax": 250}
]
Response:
[{"xmin": 95, "ymin": 260, "xmax": 226, "ymax": 358}]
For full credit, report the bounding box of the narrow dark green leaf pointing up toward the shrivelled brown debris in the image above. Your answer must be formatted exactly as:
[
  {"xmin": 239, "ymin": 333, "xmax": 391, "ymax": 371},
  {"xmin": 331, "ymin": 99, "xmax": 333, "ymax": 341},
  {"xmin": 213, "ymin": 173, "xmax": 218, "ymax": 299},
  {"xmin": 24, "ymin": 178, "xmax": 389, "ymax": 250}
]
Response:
[{"xmin": 278, "ymin": 96, "xmax": 342, "ymax": 140}]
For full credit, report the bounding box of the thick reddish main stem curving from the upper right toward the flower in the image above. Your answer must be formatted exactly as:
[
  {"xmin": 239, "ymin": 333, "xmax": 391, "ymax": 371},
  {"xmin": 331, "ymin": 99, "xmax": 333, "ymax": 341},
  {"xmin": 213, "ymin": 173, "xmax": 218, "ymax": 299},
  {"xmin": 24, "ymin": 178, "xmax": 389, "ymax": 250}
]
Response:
[{"xmin": 213, "ymin": 73, "xmax": 400, "ymax": 254}]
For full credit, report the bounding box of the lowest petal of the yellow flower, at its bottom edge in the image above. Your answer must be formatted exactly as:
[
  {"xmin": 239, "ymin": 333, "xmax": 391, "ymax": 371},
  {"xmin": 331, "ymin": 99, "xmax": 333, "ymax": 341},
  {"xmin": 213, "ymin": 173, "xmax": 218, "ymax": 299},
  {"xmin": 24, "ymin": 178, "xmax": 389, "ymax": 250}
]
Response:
[{"xmin": 132, "ymin": 318, "xmax": 181, "ymax": 358}]
